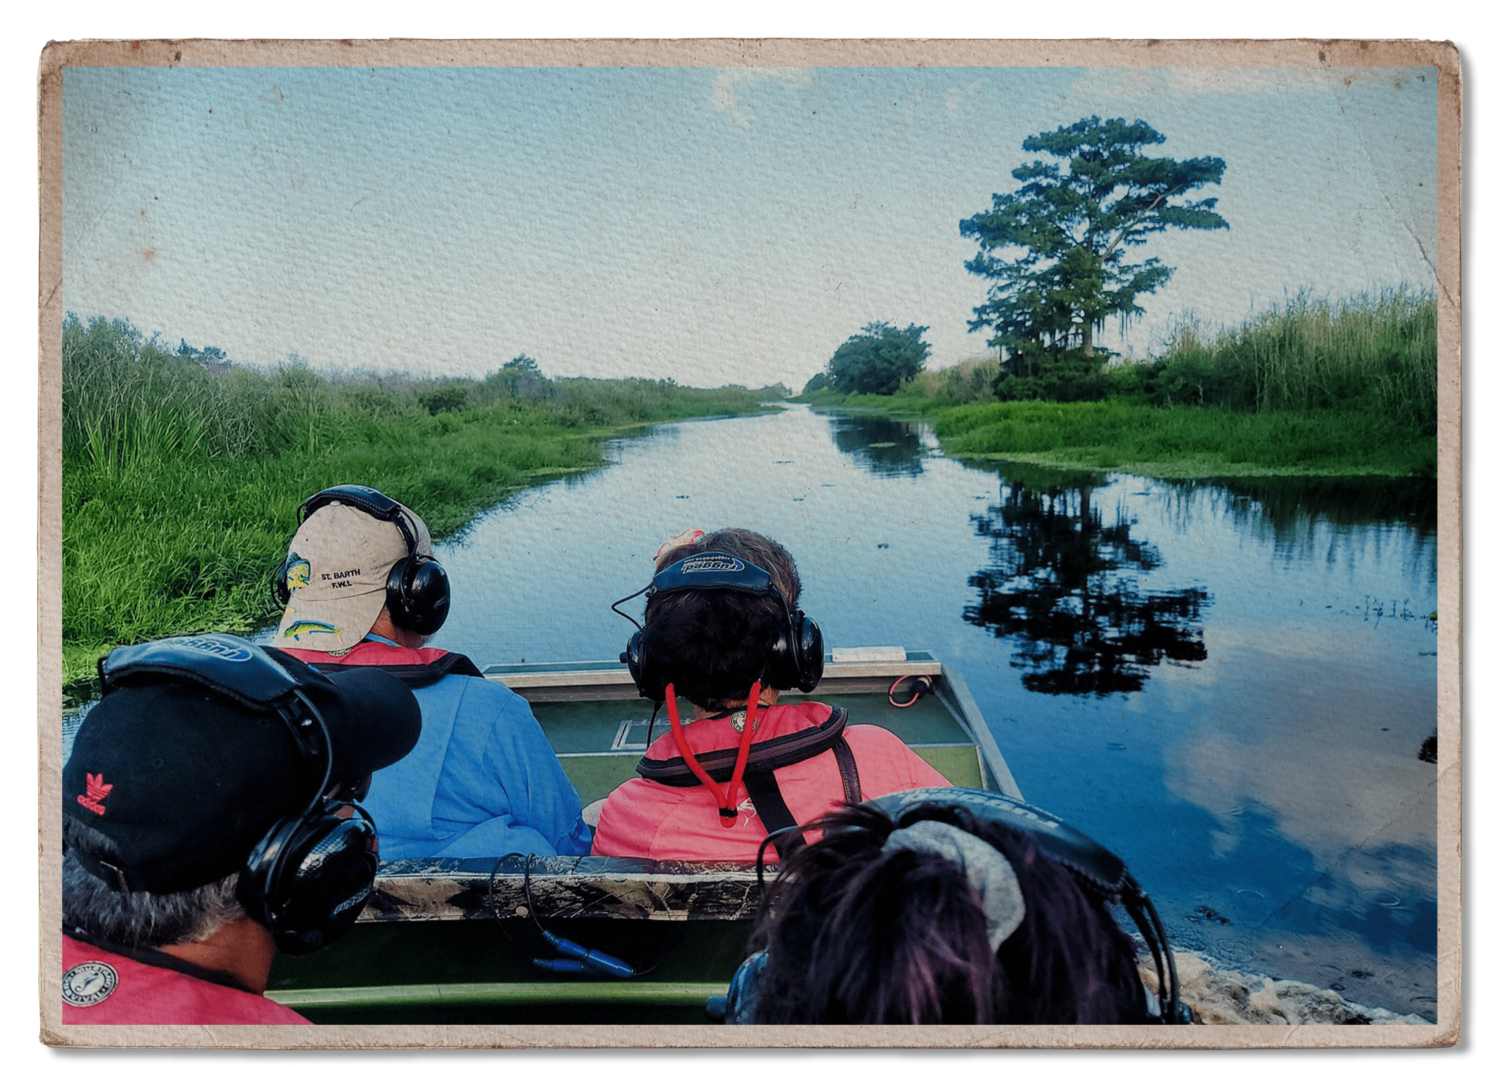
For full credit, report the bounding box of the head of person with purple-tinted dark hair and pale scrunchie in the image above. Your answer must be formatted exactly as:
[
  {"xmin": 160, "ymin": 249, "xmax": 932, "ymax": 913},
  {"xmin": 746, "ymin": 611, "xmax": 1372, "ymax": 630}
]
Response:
[{"xmin": 729, "ymin": 804, "xmax": 1157, "ymax": 1024}]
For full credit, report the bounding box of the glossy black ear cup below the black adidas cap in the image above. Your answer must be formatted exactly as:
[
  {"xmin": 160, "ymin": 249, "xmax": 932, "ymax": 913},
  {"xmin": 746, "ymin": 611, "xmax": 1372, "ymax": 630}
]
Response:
[{"xmin": 239, "ymin": 799, "xmax": 380, "ymax": 955}]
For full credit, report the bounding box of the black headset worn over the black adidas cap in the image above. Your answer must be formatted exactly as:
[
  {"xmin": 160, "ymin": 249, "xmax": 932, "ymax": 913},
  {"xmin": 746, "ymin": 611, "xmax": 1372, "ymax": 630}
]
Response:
[{"xmin": 89, "ymin": 634, "xmax": 380, "ymax": 955}]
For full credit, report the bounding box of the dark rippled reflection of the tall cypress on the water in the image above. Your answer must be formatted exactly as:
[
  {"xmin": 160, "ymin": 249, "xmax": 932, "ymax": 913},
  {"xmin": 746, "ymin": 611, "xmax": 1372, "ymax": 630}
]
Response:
[{"xmin": 963, "ymin": 471, "xmax": 1211, "ymax": 697}]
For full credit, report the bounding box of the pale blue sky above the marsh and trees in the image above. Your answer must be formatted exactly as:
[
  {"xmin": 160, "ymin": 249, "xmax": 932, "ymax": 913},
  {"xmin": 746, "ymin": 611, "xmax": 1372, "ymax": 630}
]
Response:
[{"xmin": 62, "ymin": 67, "xmax": 1439, "ymax": 388}]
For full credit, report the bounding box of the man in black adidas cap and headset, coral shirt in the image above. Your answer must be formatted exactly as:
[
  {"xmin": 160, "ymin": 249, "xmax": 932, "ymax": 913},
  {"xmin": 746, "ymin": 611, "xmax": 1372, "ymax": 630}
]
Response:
[{"xmin": 62, "ymin": 634, "xmax": 422, "ymax": 1024}]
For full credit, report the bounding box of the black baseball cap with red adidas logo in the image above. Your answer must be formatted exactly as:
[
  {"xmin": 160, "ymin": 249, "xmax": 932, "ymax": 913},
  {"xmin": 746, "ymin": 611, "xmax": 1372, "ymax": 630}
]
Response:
[{"xmin": 63, "ymin": 634, "xmax": 422, "ymax": 894}]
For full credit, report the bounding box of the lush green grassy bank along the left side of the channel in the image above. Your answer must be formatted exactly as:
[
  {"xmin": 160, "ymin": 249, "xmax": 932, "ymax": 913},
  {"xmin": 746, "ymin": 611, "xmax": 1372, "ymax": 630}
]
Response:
[{"xmin": 62, "ymin": 319, "xmax": 785, "ymax": 682}]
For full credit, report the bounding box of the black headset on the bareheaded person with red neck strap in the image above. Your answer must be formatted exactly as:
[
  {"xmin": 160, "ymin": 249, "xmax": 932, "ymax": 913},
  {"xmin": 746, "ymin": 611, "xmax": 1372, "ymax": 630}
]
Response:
[{"xmin": 611, "ymin": 552, "xmax": 824, "ymax": 705}]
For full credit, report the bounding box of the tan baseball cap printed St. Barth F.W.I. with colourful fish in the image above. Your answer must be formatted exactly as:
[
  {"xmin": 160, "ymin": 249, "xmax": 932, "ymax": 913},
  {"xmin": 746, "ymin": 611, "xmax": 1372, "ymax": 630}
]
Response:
[{"xmin": 272, "ymin": 492, "xmax": 432, "ymax": 654}]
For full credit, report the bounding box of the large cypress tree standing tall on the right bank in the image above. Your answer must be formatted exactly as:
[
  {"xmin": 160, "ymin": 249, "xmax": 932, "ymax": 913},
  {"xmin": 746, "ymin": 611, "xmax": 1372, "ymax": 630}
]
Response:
[{"xmin": 959, "ymin": 117, "xmax": 1229, "ymax": 399}]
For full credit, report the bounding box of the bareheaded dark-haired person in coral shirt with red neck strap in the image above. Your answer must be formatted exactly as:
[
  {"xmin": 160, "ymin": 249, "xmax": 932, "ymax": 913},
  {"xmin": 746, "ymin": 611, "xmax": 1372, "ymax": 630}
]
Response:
[{"xmin": 594, "ymin": 528, "xmax": 948, "ymax": 861}]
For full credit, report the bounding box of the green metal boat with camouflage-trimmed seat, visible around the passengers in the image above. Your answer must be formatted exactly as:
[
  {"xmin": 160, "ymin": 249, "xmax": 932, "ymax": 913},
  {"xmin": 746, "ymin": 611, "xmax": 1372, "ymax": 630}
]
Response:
[{"xmin": 269, "ymin": 649, "xmax": 1020, "ymax": 1024}]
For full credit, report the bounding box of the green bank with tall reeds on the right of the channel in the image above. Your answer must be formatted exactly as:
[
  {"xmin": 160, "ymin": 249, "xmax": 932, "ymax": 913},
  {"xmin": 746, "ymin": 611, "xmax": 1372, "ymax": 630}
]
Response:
[{"xmin": 800, "ymin": 289, "xmax": 1437, "ymax": 478}]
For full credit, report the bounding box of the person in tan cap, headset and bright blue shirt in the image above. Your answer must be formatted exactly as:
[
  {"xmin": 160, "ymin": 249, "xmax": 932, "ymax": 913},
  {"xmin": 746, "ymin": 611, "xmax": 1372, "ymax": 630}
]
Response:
[{"xmin": 272, "ymin": 484, "xmax": 591, "ymax": 861}]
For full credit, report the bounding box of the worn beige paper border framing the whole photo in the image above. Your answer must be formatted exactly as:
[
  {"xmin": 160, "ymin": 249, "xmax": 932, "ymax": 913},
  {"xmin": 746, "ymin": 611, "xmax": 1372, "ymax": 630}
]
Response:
[{"xmin": 36, "ymin": 39, "xmax": 1472, "ymax": 1060}]
